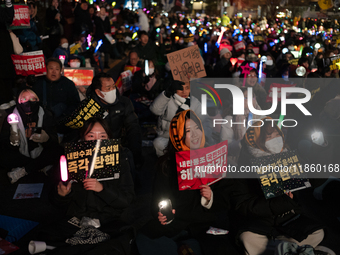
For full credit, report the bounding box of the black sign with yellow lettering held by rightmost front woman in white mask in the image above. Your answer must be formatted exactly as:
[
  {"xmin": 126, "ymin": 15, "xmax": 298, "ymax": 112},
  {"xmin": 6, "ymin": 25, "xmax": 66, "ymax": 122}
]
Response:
[{"xmin": 251, "ymin": 151, "xmax": 311, "ymax": 199}]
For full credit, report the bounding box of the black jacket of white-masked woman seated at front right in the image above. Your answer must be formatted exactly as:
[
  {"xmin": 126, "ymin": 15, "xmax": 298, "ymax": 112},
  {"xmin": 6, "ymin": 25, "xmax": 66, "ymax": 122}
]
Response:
[{"xmin": 233, "ymin": 140, "xmax": 322, "ymax": 242}]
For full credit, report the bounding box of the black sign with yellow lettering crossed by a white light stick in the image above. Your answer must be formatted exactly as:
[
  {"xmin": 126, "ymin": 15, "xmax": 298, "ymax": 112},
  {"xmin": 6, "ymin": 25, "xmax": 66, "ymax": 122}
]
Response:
[{"xmin": 65, "ymin": 139, "xmax": 120, "ymax": 182}]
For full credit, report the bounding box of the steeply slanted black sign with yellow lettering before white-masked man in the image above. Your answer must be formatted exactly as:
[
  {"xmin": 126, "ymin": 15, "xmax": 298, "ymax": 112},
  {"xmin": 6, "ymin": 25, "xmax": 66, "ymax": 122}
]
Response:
[{"xmin": 61, "ymin": 98, "xmax": 107, "ymax": 129}]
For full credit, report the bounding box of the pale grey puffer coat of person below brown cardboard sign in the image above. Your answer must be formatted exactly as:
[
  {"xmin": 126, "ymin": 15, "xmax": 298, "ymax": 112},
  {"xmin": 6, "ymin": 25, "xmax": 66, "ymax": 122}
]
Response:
[{"xmin": 150, "ymin": 92, "xmax": 204, "ymax": 138}]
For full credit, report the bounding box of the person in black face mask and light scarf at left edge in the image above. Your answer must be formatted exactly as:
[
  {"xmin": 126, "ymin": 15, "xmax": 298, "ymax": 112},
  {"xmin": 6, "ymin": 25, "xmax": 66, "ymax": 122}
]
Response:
[{"xmin": 0, "ymin": 89, "xmax": 62, "ymax": 184}]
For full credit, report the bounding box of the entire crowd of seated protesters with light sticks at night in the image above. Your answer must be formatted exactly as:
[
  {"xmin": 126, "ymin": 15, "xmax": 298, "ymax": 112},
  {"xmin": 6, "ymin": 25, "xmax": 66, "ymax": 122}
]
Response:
[{"xmin": 0, "ymin": 0, "xmax": 340, "ymax": 255}]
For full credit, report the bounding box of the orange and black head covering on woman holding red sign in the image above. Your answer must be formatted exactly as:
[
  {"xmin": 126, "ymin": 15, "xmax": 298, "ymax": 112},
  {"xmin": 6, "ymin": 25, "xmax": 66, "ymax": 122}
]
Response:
[{"xmin": 169, "ymin": 110, "xmax": 205, "ymax": 151}]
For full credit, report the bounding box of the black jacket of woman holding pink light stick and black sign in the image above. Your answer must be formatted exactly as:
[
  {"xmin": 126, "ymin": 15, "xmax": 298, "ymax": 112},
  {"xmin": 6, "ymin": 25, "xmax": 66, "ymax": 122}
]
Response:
[{"xmin": 55, "ymin": 148, "xmax": 135, "ymax": 224}]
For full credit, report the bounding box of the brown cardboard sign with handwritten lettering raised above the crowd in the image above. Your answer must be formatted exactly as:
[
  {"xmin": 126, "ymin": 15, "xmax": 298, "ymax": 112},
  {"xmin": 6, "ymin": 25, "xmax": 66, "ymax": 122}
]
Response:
[{"xmin": 167, "ymin": 45, "xmax": 207, "ymax": 82}]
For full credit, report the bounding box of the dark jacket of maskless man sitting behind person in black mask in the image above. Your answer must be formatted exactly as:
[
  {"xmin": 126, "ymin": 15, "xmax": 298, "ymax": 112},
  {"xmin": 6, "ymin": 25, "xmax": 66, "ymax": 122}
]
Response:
[{"xmin": 33, "ymin": 76, "xmax": 80, "ymax": 120}]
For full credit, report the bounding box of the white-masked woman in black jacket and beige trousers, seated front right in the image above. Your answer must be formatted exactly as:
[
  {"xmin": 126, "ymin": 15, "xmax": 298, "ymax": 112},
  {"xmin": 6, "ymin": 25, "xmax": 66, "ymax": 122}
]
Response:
[{"xmin": 233, "ymin": 117, "xmax": 324, "ymax": 255}]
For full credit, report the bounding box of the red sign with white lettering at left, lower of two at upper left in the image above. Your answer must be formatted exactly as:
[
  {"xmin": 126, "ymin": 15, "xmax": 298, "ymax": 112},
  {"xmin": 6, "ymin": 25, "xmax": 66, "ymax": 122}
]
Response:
[{"xmin": 11, "ymin": 54, "xmax": 46, "ymax": 76}]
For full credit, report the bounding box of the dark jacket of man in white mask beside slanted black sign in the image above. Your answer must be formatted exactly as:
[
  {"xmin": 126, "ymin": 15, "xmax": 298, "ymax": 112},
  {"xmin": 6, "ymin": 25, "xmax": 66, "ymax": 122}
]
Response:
[{"xmin": 86, "ymin": 86, "xmax": 142, "ymax": 163}]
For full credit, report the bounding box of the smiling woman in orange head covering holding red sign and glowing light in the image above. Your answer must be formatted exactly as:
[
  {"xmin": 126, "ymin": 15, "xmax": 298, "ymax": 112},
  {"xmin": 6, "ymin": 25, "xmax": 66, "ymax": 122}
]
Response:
[{"xmin": 136, "ymin": 110, "xmax": 237, "ymax": 255}]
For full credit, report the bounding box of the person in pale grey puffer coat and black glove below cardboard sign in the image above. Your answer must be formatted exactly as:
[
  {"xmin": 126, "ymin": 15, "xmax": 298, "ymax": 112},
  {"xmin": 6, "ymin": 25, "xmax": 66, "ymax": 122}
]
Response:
[{"xmin": 150, "ymin": 81, "xmax": 201, "ymax": 157}]
